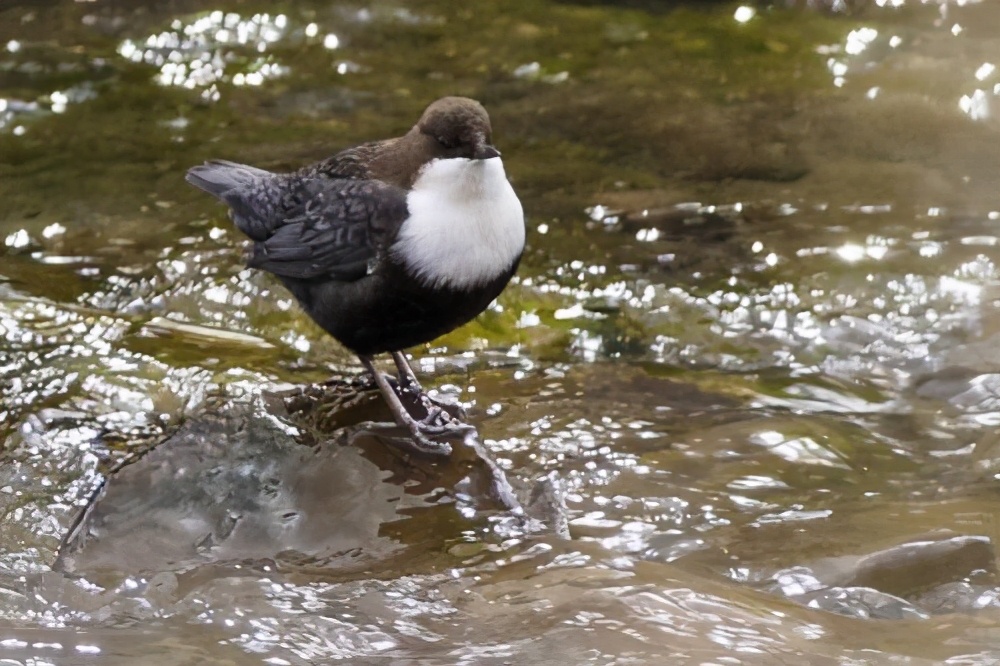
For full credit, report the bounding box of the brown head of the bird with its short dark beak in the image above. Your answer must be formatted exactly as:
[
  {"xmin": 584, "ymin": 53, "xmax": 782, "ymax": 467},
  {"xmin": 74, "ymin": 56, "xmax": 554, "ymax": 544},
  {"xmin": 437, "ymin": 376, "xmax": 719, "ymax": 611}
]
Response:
[{"xmin": 416, "ymin": 97, "xmax": 500, "ymax": 160}]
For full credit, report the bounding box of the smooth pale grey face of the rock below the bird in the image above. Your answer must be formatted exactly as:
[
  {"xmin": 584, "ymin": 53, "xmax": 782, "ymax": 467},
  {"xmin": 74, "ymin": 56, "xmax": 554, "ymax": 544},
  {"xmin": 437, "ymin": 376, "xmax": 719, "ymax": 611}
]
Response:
[{"xmin": 60, "ymin": 394, "xmax": 416, "ymax": 571}]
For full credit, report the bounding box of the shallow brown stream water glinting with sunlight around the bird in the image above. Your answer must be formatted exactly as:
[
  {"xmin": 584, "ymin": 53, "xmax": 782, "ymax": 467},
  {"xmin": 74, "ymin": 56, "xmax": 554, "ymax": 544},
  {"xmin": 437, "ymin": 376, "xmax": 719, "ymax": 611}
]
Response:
[{"xmin": 0, "ymin": 0, "xmax": 1000, "ymax": 664}]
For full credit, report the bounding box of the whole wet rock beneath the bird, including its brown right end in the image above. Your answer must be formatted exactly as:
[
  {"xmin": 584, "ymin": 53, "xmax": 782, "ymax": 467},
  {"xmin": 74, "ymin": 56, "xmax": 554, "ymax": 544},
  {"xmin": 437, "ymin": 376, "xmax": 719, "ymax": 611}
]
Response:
[{"xmin": 57, "ymin": 382, "xmax": 565, "ymax": 573}]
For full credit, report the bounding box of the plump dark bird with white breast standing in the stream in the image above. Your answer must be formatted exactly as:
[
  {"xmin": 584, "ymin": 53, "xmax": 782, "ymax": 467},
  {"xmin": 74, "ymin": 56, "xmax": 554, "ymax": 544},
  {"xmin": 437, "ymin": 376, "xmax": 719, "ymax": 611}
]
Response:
[{"xmin": 186, "ymin": 97, "xmax": 525, "ymax": 456}]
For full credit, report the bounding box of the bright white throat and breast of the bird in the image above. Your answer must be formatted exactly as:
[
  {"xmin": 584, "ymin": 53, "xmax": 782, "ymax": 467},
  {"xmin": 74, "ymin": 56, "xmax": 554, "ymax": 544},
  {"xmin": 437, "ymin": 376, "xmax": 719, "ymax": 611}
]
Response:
[{"xmin": 392, "ymin": 157, "xmax": 524, "ymax": 289}]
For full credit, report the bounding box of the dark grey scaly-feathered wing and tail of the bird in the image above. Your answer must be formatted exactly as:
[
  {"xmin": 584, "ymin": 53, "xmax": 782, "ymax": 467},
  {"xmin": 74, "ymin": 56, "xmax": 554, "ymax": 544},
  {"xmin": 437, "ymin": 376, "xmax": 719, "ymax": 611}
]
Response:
[{"xmin": 187, "ymin": 162, "xmax": 407, "ymax": 281}]
